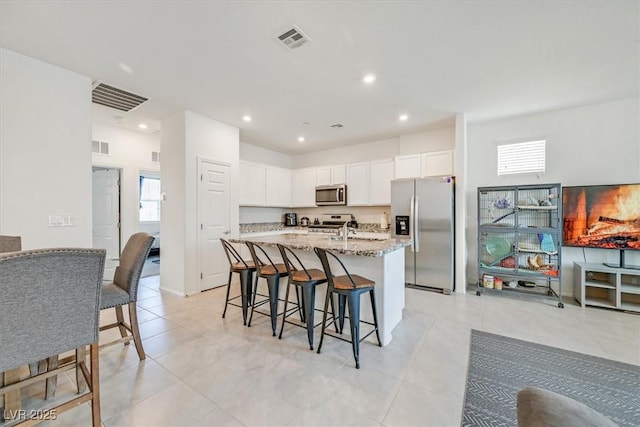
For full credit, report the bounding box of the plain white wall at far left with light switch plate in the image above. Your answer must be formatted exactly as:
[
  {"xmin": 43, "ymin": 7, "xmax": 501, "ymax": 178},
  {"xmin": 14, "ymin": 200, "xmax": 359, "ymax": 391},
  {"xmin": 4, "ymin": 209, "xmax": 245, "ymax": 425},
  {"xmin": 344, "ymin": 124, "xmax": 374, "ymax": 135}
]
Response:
[{"xmin": 0, "ymin": 48, "xmax": 92, "ymax": 249}]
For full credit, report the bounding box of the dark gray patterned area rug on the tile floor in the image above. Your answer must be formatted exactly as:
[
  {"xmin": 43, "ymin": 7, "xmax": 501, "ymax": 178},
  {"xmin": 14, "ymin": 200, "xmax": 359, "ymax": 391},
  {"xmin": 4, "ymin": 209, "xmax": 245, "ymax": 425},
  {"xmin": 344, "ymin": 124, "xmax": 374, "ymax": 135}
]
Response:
[{"xmin": 462, "ymin": 330, "xmax": 640, "ymax": 427}]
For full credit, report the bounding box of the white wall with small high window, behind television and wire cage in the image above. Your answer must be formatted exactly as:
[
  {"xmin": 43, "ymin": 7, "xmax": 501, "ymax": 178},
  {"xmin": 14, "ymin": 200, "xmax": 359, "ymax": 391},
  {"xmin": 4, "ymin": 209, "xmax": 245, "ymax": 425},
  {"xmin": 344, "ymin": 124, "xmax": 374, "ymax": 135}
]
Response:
[{"xmin": 466, "ymin": 98, "xmax": 640, "ymax": 294}]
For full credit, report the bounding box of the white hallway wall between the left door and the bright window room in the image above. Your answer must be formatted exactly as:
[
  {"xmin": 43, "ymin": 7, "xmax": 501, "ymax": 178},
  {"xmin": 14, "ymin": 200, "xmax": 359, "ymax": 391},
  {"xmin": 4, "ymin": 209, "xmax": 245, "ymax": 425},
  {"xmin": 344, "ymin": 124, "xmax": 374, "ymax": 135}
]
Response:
[{"xmin": 92, "ymin": 121, "xmax": 160, "ymax": 247}]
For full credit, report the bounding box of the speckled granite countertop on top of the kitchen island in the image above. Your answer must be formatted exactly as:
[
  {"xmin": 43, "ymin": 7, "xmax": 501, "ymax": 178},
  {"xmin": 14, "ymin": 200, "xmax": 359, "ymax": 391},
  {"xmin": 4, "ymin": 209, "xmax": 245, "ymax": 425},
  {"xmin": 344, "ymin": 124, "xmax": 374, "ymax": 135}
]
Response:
[{"xmin": 229, "ymin": 233, "xmax": 411, "ymax": 257}]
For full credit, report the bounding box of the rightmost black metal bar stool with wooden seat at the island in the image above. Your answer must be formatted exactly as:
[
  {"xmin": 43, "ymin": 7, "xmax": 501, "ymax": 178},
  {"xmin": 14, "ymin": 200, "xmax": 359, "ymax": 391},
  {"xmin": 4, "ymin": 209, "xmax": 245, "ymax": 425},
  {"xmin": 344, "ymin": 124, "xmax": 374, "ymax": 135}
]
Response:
[{"xmin": 313, "ymin": 247, "xmax": 382, "ymax": 369}]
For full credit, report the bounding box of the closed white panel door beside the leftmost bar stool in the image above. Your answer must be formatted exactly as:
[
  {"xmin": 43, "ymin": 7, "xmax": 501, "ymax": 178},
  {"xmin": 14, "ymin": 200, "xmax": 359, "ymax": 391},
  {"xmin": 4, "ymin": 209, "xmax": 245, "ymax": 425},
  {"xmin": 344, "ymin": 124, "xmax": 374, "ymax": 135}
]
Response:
[{"xmin": 198, "ymin": 160, "xmax": 231, "ymax": 291}]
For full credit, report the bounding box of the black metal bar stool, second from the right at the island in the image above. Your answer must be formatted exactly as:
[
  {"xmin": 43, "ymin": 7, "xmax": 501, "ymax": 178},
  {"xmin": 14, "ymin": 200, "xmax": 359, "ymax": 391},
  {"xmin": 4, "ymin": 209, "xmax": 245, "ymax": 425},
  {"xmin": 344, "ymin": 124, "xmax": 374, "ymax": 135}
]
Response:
[{"xmin": 278, "ymin": 243, "xmax": 338, "ymax": 350}]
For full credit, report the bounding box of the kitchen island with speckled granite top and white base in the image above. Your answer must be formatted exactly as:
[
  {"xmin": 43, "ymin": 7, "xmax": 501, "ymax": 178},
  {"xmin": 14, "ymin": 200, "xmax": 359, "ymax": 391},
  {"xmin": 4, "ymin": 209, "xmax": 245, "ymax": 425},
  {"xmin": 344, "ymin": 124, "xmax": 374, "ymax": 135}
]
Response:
[{"xmin": 230, "ymin": 234, "xmax": 411, "ymax": 345}]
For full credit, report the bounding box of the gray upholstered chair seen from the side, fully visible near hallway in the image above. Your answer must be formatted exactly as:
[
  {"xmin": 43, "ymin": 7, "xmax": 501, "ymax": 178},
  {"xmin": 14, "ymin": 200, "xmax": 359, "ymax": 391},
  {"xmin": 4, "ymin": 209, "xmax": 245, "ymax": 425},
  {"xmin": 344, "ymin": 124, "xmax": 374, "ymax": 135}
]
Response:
[{"xmin": 100, "ymin": 232, "xmax": 153, "ymax": 360}]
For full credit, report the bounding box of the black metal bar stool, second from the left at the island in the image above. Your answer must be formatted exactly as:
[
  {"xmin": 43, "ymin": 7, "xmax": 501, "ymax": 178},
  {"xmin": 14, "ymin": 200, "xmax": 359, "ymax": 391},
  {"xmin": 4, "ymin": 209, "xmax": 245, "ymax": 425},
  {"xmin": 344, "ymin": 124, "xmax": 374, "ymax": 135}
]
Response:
[{"xmin": 246, "ymin": 241, "xmax": 300, "ymax": 337}]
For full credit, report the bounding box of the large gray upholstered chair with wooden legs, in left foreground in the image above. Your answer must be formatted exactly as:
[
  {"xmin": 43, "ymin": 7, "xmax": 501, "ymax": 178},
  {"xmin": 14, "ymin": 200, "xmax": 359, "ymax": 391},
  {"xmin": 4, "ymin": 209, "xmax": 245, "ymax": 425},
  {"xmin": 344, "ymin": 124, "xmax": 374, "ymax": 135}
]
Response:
[{"xmin": 0, "ymin": 248, "xmax": 106, "ymax": 426}]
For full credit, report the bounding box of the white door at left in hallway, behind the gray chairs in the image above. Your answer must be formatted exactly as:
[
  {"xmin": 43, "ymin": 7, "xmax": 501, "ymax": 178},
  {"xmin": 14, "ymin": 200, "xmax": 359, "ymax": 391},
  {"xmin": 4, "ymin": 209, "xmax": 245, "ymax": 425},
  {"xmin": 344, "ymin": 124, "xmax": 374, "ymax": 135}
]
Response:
[{"xmin": 93, "ymin": 168, "xmax": 120, "ymax": 280}]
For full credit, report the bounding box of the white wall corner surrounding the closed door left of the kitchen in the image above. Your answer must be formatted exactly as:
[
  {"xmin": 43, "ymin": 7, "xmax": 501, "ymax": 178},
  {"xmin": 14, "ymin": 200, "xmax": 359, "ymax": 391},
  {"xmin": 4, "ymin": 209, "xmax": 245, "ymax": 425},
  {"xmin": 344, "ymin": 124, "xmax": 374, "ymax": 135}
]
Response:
[{"xmin": 160, "ymin": 111, "xmax": 240, "ymax": 295}]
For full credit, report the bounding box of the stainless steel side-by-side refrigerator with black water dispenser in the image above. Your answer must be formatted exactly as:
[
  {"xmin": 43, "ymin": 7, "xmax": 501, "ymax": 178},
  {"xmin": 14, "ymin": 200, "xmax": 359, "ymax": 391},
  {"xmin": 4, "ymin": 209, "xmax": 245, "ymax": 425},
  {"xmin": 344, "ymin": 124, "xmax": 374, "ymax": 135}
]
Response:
[{"xmin": 391, "ymin": 177, "xmax": 455, "ymax": 294}]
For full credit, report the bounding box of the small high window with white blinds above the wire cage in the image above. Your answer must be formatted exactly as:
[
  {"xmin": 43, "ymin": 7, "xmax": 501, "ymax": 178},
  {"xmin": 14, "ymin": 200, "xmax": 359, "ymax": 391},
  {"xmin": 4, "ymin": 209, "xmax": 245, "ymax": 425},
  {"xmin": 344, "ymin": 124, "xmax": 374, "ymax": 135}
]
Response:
[{"xmin": 498, "ymin": 139, "xmax": 547, "ymax": 176}]
